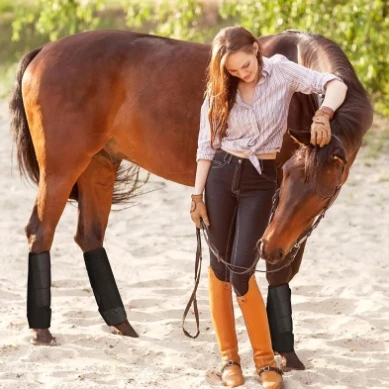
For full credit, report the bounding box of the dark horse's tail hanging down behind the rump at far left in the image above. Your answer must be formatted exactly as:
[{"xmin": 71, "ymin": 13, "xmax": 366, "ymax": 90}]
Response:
[{"xmin": 9, "ymin": 47, "xmax": 42, "ymax": 184}]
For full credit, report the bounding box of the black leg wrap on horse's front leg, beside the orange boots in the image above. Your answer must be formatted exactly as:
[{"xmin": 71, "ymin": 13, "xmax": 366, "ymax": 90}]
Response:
[{"xmin": 266, "ymin": 284, "xmax": 294, "ymax": 352}]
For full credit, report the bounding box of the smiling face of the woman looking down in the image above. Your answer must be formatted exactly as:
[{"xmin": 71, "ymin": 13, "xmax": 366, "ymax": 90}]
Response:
[{"xmin": 225, "ymin": 43, "xmax": 258, "ymax": 82}]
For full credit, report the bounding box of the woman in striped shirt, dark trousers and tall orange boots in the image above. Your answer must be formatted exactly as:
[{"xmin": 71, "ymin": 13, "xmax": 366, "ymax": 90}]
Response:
[{"xmin": 191, "ymin": 27, "xmax": 347, "ymax": 389}]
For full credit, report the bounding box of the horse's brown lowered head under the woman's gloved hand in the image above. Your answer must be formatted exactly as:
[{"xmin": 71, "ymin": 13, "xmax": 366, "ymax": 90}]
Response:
[{"xmin": 259, "ymin": 132, "xmax": 348, "ymax": 264}]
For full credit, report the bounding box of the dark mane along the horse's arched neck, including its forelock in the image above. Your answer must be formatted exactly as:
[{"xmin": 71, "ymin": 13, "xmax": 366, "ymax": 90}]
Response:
[{"xmin": 282, "ymin": 30, "xmax": 373, "ymax": 181}]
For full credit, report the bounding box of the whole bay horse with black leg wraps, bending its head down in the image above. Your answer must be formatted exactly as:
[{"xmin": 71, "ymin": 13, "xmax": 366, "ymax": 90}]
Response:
[{"xmin": 10, "ymin": 30, "xmax": 372, "ymax": 369}]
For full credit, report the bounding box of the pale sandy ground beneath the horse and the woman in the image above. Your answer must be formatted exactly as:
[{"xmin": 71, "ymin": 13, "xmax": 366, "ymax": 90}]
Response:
[{"xmin": 0, "ymin": 98, "xmax": 389, "ymax": 389}]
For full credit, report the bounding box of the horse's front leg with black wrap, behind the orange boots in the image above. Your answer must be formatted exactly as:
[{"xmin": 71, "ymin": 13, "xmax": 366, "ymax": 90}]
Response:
[{"xmin": 266, "ymin": 242, "xmax": 305, "ymax": 371}]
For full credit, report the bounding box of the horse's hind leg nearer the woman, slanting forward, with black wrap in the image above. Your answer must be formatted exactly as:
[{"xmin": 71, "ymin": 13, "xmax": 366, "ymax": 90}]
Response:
[{"xmin": 75, "ymin": 152, "xmax": 138, "ymax": 337}]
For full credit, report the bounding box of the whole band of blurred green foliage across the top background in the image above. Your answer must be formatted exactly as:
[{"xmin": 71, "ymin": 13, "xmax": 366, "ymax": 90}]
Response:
[{"xmin": 5, "ymin": 0, "xmax": 389, "ymax": 116}]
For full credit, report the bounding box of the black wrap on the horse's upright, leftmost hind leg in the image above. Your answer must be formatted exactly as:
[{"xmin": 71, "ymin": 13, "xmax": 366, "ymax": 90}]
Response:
[{"xmin": 27, "ymin": 251, "xmax": 51, "ymax": 329}]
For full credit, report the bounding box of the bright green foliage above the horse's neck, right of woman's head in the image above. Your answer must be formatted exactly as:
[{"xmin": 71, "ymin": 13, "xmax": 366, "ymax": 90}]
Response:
[{"xmin": 220, "ymin": 0, "xmax": 389, "ymax": 116}]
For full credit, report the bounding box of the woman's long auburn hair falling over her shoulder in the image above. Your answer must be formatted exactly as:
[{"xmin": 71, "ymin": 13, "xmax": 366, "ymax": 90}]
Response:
[{"xmin": 205, "ymin": 26, "xmax": 262, "ymax": 147}]
